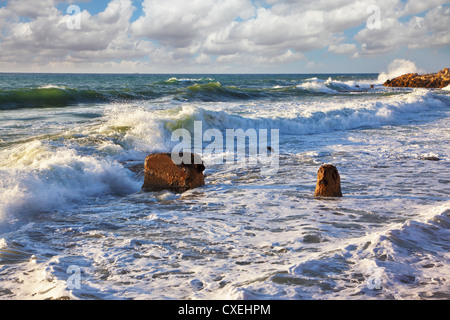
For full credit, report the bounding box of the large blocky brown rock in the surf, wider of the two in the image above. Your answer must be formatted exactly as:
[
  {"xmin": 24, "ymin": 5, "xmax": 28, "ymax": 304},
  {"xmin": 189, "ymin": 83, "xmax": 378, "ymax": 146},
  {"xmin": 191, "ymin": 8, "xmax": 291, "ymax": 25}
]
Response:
[{"xmin": 142, "ymin": 153, "xmax": 205, "ymax": 192}]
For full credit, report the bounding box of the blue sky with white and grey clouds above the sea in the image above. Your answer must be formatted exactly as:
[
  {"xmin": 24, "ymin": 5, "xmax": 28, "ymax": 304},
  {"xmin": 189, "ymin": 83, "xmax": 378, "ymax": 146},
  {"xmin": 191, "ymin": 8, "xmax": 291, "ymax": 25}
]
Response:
[{"xmin": 0, "ymin": 0, "xmax": 450, "ymax": 73}]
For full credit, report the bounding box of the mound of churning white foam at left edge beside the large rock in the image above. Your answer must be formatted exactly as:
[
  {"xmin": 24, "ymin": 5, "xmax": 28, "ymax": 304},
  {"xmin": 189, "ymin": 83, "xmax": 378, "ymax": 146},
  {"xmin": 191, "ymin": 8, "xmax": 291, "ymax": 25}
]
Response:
[{"xmin": 0, "ymin": 140, "xmax": 140, "ymax": 224}]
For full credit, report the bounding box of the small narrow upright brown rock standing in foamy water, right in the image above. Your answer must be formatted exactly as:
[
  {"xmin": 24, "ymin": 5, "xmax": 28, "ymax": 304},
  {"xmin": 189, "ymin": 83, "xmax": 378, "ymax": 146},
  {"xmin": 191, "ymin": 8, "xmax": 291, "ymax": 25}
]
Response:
[{"xmin": 314, "ymin": 165, "xmax": 342, "ymax": 197}]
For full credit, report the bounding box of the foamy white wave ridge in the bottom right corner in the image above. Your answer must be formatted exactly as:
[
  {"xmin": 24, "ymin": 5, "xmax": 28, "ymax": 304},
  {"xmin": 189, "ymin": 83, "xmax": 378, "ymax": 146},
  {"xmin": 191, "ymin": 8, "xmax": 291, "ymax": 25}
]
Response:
[{"xmin": 286, "ymin": 204, "xmax": 450, "ymax": 299}]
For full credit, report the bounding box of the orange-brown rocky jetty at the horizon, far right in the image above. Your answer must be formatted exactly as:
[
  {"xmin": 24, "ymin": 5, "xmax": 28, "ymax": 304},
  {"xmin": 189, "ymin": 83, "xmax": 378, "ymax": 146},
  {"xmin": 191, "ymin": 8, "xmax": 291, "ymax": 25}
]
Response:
[{"xmin": 383, "ymin": 68, "xmax": 450, "ymax": 88}]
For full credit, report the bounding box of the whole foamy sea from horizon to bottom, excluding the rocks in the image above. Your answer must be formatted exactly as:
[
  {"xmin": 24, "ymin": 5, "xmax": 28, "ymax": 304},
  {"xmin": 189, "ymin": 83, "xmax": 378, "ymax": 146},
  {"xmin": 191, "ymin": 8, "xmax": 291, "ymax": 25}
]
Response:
[{"xmin": 0, "ymin": 74, "xmax": 450, "ymax": 300}]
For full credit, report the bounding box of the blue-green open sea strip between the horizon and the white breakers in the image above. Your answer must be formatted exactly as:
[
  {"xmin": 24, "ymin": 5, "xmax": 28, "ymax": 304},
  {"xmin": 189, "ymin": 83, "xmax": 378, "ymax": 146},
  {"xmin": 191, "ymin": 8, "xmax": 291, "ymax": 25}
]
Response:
[{"xmin": 0, "ymin": 74, "xmax": 376, "ymax": 109}]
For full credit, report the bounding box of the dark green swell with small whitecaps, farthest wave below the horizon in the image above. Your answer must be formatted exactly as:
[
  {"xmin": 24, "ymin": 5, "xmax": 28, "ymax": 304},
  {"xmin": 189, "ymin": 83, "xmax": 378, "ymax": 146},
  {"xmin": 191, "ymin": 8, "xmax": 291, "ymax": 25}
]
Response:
[{"xmin": 0, "ymin": 78, "xmax": 386, "ymax": 110}]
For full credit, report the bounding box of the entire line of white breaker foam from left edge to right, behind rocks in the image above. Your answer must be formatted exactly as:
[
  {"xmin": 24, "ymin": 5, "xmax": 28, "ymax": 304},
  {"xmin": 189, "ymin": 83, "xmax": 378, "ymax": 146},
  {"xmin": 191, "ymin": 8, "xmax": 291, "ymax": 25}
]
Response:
[{"xmin": 0, "ymin": 89, "xmax": 445, "ymax": 225}]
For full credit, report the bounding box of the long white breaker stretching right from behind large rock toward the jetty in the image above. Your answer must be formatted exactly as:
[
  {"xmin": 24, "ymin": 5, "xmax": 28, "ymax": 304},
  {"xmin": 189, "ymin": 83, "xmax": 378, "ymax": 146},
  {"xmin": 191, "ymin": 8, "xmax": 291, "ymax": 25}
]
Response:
[{"xmin": 182, "ymin": 90, "xmax": 445, "ymax": 134}]
